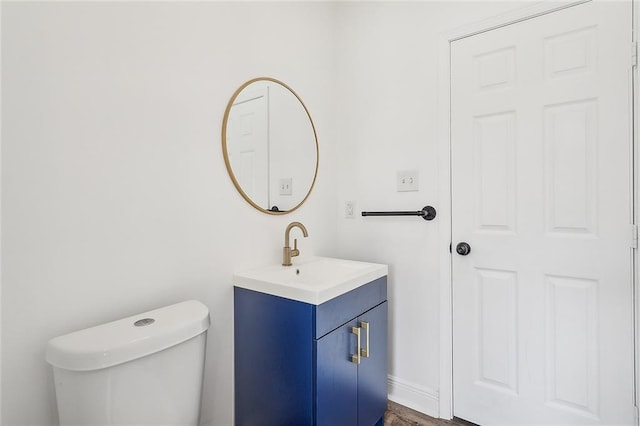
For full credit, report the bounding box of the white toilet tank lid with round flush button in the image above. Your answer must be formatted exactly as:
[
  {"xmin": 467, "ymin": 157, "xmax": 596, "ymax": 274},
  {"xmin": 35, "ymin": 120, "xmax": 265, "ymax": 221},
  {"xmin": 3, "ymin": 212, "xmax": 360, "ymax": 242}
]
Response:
[{"xmin": 46, "ymin": 300, "xmax": 209, "ymax": 371}]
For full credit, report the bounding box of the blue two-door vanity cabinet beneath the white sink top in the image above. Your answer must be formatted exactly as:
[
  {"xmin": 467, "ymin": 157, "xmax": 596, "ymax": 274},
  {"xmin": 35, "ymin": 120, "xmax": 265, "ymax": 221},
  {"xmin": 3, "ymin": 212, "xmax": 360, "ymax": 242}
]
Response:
[{"xmin": 234, "ymin": 276, "xmax": 387, "ymax": 426}]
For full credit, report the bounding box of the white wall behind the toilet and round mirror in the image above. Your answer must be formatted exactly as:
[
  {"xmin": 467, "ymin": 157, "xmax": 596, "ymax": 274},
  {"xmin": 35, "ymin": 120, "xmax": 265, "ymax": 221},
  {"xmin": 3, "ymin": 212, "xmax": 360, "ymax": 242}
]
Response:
[{"xmin": 2, "ymin": 2, "xmax": 337, "ymax": 426}]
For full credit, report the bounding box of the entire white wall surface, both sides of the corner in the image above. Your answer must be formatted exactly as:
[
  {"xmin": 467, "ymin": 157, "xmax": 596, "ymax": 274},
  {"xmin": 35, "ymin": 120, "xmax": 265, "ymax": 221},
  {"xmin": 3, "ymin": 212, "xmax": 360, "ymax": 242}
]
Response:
[{"xmin": 2, "ymin": 2, "xmax": 552, "ymax": 426}]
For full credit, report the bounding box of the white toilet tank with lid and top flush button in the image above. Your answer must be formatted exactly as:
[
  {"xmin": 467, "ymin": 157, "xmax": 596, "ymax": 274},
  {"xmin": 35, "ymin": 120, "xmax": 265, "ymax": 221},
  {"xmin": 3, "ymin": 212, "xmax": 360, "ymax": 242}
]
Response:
[{"xmin": 46, "ymin": 300, "xmax": 209, "ymax": 426}]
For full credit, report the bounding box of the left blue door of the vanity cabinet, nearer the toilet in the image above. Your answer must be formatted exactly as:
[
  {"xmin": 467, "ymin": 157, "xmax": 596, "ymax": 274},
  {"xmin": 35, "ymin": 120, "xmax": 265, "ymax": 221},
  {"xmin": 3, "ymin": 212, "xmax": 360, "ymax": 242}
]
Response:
[{"xmin": 314, "ymin": 320, "xmax": 358, "ymax": 426}]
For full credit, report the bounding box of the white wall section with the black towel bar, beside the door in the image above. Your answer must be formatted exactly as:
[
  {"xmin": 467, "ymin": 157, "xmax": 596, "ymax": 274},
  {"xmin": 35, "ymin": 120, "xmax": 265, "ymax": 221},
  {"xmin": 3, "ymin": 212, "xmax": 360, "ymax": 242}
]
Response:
[{"xmin": 335, "ymin": 2, "xmax": 527, "ymax": 416}]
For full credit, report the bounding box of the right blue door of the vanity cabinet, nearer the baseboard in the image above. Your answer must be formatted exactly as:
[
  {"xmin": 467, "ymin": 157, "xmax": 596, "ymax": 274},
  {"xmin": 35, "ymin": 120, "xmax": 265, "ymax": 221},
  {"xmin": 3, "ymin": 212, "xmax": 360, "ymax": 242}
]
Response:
[{"xmin": 353, "ymin": 302, "xmax": 387, "ymax": 426}]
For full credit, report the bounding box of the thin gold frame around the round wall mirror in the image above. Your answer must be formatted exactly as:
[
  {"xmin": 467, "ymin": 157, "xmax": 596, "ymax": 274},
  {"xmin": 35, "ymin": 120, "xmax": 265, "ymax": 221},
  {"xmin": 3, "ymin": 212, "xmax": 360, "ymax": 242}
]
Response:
[{"xmin": 222, "ymin": 77, "xmax": 320, "ymax": 215}]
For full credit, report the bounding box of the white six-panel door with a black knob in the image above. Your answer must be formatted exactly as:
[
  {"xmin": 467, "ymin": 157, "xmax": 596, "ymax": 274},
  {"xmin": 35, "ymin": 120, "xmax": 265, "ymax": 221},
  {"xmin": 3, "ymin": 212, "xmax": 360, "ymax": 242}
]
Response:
[{"xmin": 451, "ymin": 2, "xmax": 634, "ymax": 426}]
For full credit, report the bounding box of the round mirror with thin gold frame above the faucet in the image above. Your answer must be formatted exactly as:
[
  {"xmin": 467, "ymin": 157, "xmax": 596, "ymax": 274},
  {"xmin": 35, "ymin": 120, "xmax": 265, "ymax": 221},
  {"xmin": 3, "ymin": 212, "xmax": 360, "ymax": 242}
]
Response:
[{"xmin": 222, "ymin": 77, "xmax": 318, "ymax": 214}]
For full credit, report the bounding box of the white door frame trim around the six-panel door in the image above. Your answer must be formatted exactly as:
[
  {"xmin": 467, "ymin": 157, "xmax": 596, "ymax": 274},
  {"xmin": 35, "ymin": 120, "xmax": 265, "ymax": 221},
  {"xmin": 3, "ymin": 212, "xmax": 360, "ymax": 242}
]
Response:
[{"xmin": 437, "ymin": 0, "xmax": 640, "ymax": 425}]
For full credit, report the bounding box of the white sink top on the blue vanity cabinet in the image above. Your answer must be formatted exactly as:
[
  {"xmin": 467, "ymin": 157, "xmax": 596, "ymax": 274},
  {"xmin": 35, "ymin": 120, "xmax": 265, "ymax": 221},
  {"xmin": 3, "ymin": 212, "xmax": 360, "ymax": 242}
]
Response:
[{"xmin": 233, "ymin": 257, "xmax": 388, "ymax": 305}]
